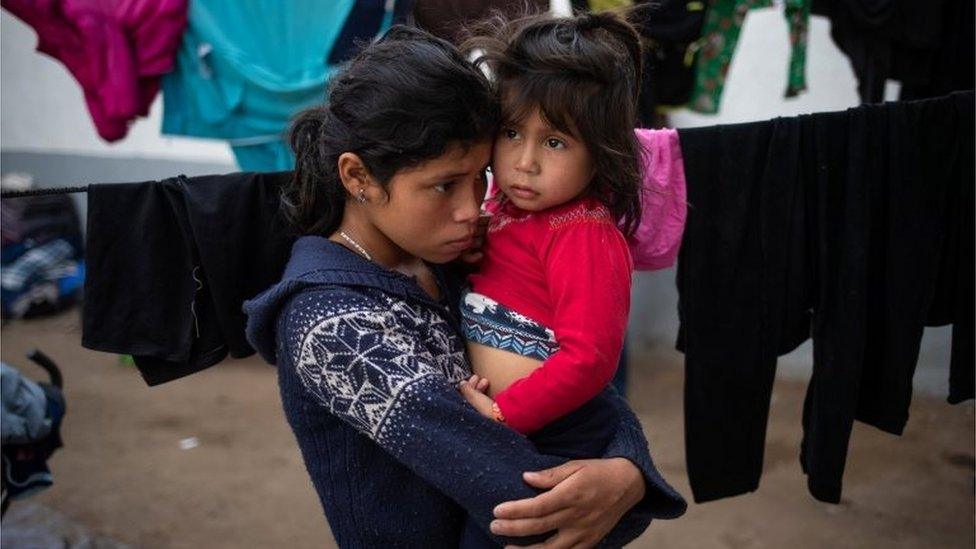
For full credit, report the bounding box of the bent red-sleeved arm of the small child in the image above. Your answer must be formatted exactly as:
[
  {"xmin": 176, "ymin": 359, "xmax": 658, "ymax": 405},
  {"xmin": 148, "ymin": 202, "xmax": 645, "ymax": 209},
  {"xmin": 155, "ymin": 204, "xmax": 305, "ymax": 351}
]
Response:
[{"xmin": 495, "ymin": 216, "xmax": 632, "ymax": 433}]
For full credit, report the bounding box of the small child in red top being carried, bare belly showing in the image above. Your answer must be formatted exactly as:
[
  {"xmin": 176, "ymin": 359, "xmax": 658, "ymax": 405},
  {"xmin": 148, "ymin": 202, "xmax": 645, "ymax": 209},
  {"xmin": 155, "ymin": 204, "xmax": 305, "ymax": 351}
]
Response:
[{"xmin": 461, "ymin": 13, "xmax": 641, "ymax": 458}]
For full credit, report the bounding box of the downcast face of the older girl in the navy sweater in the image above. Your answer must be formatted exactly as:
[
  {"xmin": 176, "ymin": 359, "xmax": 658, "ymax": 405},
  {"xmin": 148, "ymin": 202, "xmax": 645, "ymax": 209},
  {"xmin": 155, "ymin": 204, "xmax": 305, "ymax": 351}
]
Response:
[{"xmin": 369, "ymin": 141, "xmax": 491, "ymax": 263}]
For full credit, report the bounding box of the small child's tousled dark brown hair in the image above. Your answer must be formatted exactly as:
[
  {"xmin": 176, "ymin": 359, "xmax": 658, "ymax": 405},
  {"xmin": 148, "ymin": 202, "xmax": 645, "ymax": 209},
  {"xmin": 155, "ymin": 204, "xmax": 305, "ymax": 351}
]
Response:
[{"xmin": 462, "ymin": 12, "xmax": 642, "ymax": 235}]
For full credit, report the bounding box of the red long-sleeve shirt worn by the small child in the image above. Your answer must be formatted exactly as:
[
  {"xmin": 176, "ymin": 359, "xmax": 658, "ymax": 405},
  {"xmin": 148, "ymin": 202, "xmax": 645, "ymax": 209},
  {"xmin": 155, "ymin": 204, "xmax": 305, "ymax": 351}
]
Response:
[{"xmin": 470, "ymin": 199, "xmax": 633, "ymax": 433}]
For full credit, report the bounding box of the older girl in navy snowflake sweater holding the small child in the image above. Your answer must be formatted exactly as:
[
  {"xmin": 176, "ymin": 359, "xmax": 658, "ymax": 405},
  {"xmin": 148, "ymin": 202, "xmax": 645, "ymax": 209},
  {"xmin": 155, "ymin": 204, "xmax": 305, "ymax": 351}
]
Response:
[{"xmin": 245, "ymin": 23, "xmax": 684, "ymax": 547}]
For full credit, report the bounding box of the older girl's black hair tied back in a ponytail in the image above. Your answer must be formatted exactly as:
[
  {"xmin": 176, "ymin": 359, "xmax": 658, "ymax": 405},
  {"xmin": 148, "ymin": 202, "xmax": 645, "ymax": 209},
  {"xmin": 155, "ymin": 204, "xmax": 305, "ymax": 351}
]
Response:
[{"xmin": 282, "ymin": 25, "xmax": 498, "ymax": 236}]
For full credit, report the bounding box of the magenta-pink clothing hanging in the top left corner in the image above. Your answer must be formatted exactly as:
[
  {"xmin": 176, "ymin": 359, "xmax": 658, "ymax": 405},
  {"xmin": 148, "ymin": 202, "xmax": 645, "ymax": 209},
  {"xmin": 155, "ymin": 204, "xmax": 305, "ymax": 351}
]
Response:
[{"xmin": 0, "ymin": 0, "xmax": 187, "ymax": 141}]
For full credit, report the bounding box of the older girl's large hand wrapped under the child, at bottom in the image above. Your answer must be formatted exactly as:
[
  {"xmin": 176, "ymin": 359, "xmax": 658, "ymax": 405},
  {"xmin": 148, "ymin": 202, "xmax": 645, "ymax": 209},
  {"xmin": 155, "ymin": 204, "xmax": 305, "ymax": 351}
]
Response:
[{"xmin": 491, "ymin": 458, "xmax": 646, "ymax": 548}]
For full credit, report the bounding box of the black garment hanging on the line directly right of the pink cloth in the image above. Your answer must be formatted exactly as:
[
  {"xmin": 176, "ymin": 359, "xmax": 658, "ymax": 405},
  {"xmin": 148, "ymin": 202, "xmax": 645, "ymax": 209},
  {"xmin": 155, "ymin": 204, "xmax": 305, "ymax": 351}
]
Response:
[{"xmin": 677, "ymin": 114, "xmax": 811, "ymax": 502}]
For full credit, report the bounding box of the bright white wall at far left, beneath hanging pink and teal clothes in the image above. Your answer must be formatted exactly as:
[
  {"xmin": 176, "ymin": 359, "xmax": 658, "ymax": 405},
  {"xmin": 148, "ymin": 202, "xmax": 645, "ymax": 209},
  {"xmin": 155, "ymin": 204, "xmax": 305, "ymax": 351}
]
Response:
[{"xmin": 0, "ymin": 11, "xmax": 234, "ymax": 164}]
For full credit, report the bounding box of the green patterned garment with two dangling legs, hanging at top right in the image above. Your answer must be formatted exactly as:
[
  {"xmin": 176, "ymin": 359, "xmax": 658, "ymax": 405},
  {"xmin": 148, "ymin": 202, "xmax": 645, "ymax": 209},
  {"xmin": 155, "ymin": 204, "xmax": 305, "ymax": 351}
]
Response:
[{"xmin": 689, "ymin": 0, "xmax": 811, "ymax": 113}]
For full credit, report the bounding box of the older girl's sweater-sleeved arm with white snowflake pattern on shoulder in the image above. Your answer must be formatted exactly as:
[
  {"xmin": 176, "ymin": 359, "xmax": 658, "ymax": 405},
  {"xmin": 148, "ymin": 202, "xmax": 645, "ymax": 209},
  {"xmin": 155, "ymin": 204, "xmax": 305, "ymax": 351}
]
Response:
[{"xmin": 282, "ymin": 291, "xmax": 684, "ymax": 542}]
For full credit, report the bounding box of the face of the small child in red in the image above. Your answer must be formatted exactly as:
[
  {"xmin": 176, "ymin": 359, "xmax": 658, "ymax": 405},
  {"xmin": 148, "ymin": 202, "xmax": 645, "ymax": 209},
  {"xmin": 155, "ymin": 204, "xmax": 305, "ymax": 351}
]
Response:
[{"xmin": 492, "ymin": 107, "xmax": 594, "ymax": 212}]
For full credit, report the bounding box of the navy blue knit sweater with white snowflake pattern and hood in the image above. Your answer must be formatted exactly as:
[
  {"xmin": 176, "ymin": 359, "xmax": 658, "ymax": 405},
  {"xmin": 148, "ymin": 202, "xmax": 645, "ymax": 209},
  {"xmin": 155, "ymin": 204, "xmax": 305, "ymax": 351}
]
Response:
[{"xmin": 244, "ymin": 236, "xmax": 685, "ymax": 548}]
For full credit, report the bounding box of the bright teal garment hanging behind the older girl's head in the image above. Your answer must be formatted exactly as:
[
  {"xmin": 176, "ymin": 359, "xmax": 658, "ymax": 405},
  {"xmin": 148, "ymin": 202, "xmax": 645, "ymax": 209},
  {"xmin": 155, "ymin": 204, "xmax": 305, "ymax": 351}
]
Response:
[{"xmin": 162, "ymin": 0, "xmax": 355, "ymax": 158}]
